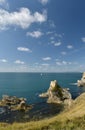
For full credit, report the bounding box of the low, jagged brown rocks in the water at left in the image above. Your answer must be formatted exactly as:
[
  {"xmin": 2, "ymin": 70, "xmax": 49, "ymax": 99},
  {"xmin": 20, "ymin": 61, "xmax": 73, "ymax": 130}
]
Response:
[{"xmin": 0, "ymin": 95, "xmax": 32, "ymax": 111}]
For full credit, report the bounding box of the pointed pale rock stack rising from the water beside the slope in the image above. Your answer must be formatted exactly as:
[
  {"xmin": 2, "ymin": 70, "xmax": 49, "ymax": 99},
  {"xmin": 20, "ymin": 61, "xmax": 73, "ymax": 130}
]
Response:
[{"xmin": 39, "ymin": 80, "xmax": 72, "ymax": 106}]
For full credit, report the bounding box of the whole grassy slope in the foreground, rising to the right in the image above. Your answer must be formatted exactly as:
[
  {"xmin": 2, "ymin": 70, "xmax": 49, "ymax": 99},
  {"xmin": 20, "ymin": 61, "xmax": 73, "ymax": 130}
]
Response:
[{"xmin": 0, "ymin": 93, "xmax": 85, "ymax": 130}]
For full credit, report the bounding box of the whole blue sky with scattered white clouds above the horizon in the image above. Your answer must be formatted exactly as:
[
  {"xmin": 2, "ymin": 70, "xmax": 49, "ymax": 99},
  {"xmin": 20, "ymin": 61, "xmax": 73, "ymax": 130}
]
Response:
[{"xmin": 0, "ymin": 0, "xmax": 85, "ymax": 72}]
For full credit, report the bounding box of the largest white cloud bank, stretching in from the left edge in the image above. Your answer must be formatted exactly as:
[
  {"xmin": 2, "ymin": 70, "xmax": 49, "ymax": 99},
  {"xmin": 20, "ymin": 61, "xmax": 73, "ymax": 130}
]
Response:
[{"xmin": 0, "ymin": 8, "xmax": 47, "ymax": 30}]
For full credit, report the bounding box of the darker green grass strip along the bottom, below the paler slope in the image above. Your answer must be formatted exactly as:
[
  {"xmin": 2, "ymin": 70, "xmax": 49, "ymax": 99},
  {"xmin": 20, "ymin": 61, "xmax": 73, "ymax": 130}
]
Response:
[{"xmin": 0, "ymin": 116, "xmax": 85, "ymax": 130}]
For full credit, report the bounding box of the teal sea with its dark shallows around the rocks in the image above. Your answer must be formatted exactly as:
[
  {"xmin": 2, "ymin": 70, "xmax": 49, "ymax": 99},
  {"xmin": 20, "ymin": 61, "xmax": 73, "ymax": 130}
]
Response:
[{"xmin": 0, "ymin": 72, "xmax": 85, "ymax": 122}]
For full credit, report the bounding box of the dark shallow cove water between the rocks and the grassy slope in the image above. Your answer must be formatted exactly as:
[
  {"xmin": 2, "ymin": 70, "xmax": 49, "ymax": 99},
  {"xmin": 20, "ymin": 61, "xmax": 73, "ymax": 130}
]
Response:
[{"xmin": 0, "ymin": 99, "xmax": 63, "ymax": 123}]
